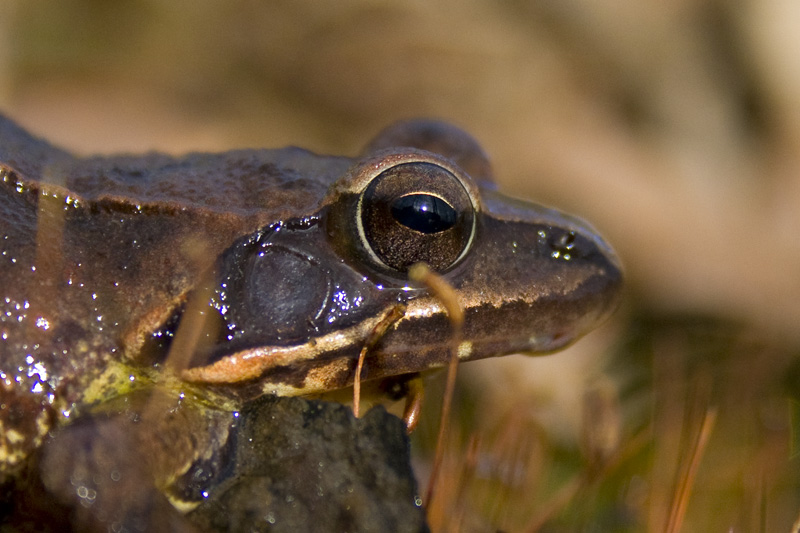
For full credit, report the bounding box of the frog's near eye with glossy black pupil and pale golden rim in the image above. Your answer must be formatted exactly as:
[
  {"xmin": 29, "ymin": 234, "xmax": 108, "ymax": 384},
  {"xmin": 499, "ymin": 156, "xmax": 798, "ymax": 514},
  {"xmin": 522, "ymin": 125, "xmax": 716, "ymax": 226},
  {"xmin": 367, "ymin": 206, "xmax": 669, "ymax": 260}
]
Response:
[{"xmin": 357, "ymin": 162, "xmax": 475, "ymax": 272}]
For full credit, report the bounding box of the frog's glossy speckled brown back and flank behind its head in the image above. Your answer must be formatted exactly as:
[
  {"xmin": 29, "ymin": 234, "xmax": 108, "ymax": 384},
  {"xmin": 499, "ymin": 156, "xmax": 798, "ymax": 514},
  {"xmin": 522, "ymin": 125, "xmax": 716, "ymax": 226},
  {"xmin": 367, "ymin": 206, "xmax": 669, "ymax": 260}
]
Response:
[{"xmin": 0, "ymin": 116, "xmax": 350, "ymax": 483}]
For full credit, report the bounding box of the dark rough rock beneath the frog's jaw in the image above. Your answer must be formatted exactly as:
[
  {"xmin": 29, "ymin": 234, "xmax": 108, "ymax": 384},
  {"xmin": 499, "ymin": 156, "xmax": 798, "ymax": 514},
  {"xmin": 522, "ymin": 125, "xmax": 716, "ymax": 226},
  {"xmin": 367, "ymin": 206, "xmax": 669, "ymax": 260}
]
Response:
[{"xmin": 189, "ymin": 398, "xmax": 427, "ymax": 532}]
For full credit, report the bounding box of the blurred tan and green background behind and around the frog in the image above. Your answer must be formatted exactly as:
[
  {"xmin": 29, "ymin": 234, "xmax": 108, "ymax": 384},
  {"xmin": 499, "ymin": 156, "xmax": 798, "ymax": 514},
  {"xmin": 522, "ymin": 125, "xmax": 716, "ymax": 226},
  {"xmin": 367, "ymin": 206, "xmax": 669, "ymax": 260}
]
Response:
[{"xmin": 0, "ymin": 0, "xmax": 800, "ymax": 531}]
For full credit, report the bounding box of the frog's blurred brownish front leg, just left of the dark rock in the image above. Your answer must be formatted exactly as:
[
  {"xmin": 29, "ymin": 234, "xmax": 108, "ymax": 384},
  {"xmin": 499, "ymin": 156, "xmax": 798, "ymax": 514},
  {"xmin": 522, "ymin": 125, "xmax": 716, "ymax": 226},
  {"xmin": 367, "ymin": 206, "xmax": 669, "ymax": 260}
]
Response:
[{"xmin": 10, "ymin": 389, "xmax": 235, "ymax": 532}]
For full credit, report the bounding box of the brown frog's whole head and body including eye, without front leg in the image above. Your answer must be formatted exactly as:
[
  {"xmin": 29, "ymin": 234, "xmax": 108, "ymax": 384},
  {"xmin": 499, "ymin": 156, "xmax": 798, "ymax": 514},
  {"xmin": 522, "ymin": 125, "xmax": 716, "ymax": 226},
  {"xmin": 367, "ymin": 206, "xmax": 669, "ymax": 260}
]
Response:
[{"xmin": 0, "ymin": 114, "xmax": 622, "ymax": 484}]
